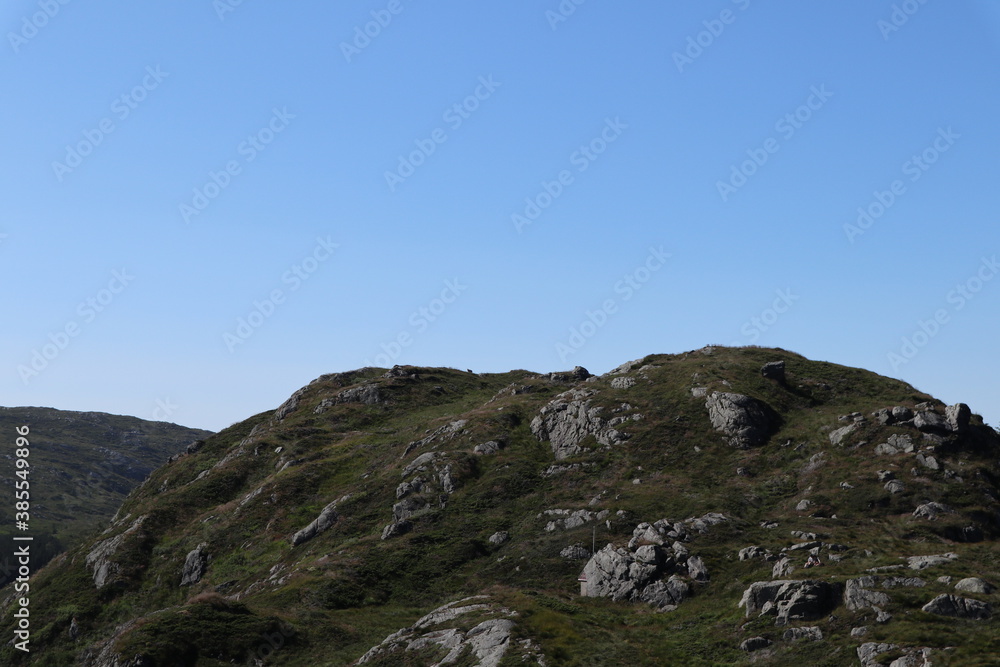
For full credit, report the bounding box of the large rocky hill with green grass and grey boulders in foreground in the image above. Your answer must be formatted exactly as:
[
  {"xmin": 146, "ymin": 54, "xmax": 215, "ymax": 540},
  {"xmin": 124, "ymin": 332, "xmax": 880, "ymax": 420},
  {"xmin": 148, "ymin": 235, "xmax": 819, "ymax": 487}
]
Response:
[{"xmin": 0, "ymin": 347, "xmax": 1000, "ymax": 667}]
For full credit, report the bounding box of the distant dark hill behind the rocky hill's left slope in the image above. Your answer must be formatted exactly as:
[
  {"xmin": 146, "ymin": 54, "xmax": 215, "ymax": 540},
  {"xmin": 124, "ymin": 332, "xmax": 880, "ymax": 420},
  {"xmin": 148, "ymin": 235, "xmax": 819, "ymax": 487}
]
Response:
[{"xmin": 0, "ymin": 408, "xmax": 211, "ymax": 585}]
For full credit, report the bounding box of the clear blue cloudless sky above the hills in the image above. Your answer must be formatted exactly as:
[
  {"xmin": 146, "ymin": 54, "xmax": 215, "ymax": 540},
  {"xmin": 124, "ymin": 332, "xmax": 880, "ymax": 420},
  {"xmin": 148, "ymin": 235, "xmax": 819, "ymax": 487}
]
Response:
[{"xmin": 0, "ymin": 0, "xmax": 1000, "ymax": 430}]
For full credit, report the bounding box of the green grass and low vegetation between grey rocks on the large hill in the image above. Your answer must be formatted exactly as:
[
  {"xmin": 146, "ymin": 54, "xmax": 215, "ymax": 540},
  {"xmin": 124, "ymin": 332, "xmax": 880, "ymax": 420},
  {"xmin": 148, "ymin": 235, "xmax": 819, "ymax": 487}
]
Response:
[{"xmin": 0, "ymin": 348, "xmax": 1000, "ymax": 666}]
